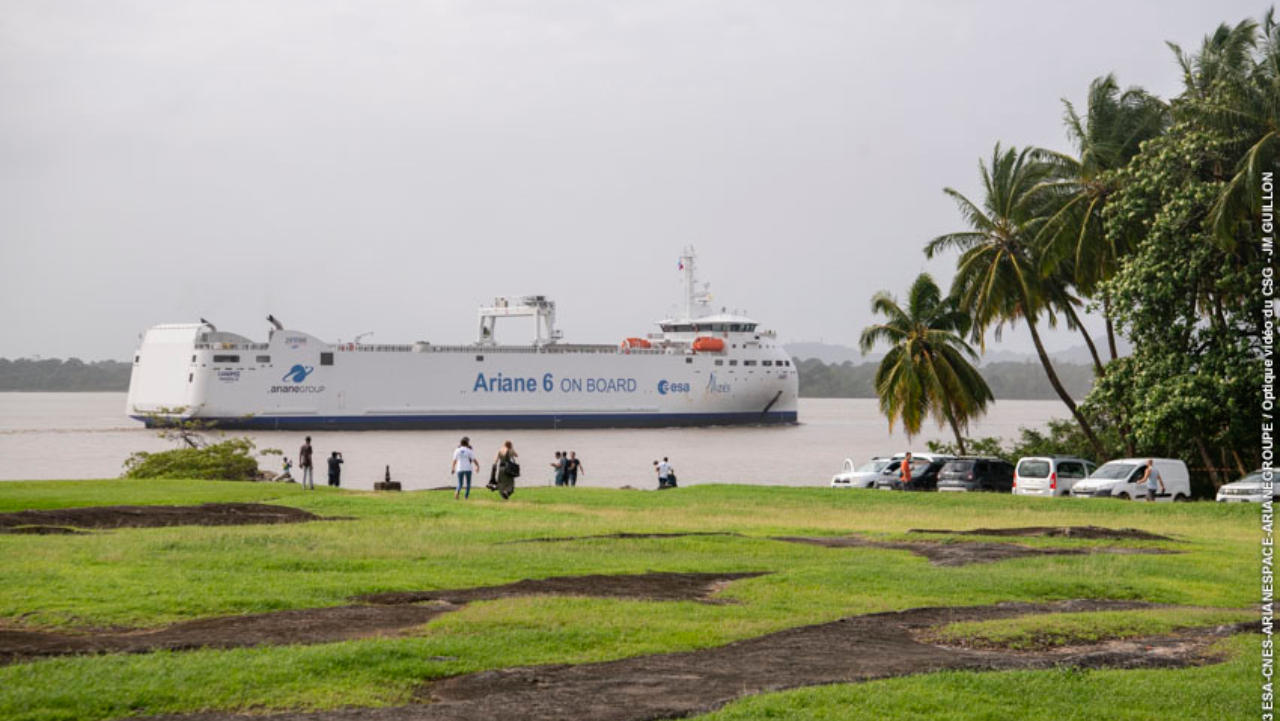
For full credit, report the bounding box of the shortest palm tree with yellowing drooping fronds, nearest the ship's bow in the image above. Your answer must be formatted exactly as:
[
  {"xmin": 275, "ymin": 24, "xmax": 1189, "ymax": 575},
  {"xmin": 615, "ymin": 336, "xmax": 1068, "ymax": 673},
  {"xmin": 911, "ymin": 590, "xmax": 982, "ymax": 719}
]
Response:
[{"xmin": 859, "ymin": 273, "xmax": 993, "ymax": 455}]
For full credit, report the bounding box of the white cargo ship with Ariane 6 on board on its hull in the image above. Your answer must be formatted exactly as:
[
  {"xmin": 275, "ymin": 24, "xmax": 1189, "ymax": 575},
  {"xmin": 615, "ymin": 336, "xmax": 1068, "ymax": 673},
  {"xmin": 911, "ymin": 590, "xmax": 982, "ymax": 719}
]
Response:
[{"xmin": 127, "ymin": 248, "xmax": 799, "ymax": 430}]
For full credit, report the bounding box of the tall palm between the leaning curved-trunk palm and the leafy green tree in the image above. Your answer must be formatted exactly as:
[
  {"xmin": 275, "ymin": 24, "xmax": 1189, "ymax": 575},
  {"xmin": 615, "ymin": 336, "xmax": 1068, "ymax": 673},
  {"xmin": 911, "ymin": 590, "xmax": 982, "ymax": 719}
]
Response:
[{"xmin": 1038, "ymin": 74, "xmax": 1170, "ymax": 363}]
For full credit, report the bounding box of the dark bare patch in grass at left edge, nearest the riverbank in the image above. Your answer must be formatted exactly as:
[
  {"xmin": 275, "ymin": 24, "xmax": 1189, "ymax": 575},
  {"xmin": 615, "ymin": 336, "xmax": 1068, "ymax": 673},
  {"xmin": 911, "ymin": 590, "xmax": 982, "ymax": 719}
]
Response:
[{"xmin": 0, "ymin": 503, "xmax": 329, "ymax": 533}]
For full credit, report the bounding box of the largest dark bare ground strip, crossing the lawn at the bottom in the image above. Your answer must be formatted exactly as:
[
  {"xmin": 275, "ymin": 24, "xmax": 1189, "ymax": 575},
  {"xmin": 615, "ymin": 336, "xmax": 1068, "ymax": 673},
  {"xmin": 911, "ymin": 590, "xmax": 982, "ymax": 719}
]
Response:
[{"xmin": 147, "ymin": 601, "xmax": 1230, "ymax": 721}]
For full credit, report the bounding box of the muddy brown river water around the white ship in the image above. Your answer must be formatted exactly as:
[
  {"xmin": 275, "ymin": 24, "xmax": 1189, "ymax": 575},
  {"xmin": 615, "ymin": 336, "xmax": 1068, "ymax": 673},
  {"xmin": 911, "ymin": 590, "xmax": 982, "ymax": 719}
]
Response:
[{"xmin": 0, "ymin": 393, "xmax": 1068, "ymax": 490}]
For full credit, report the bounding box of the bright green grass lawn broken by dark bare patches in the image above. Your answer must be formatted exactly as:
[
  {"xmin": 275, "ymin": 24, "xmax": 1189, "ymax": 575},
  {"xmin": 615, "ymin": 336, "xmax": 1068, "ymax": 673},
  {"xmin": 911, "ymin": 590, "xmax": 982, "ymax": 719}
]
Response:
[{"xmin": 0, "ymin": 480, "xmax": 1258, "ymax": 720}]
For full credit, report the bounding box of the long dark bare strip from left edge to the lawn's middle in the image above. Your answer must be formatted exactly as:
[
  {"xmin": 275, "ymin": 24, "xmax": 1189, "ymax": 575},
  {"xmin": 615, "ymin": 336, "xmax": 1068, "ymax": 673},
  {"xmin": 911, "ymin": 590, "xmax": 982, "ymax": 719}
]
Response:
[{"xmin": 0, "ymin": 574, "xmax": 763, "ymax": 663}]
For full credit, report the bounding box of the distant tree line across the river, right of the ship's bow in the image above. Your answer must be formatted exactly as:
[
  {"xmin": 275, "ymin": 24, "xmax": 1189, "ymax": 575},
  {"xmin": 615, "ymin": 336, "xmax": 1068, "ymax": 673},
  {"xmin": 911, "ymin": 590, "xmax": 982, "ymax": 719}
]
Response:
[{"xmin": 796, "ymin": 359, "xmax": 1093, "ymax": 401}]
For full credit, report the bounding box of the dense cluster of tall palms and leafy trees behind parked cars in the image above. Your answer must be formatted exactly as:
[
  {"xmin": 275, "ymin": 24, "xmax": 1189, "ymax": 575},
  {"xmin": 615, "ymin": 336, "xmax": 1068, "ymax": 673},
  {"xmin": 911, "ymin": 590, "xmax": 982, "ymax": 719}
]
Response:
[{"xmin": 875, "ymin": 12, "xmax": 1280, "ymax": 485}]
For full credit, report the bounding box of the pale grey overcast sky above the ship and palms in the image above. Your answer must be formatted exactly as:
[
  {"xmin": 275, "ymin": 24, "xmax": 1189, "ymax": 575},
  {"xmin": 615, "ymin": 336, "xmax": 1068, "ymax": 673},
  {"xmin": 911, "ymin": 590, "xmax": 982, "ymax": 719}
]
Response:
[{"xmin": 0, "ymin": 0, "xmax": 1266, "ymax": 359}]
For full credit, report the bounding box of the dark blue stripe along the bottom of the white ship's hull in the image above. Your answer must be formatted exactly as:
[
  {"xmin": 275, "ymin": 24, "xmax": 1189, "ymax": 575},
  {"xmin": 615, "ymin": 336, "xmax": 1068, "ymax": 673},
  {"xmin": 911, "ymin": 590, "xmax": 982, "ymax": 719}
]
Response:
[{"xmin": 132, "ymin": 411, "xmax": 799, "ymax": 430}]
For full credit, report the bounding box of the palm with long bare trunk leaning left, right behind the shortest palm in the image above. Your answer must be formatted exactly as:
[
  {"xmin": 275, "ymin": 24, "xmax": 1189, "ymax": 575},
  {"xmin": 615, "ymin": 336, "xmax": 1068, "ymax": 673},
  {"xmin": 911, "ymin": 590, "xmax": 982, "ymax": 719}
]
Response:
[{"xmin": 924, "ymin": 143, "xmax": 1106, "ymax": 457}]
